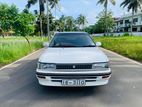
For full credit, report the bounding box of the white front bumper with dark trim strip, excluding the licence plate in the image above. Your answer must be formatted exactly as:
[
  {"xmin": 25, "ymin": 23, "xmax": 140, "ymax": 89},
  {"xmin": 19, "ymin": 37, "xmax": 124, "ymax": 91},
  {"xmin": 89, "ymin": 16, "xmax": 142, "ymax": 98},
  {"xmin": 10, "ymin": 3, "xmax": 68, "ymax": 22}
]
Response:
[{"xmin": 36, "ymin": 69, "xmax": 111, "ymax": 87}]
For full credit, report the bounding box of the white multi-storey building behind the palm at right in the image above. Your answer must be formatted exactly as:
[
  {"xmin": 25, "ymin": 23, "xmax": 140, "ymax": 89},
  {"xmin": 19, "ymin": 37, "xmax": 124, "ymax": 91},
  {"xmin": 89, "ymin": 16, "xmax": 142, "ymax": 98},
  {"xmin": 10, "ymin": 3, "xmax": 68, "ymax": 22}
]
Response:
[{"xmin": 114, "ymin": 12, "xmax": 142, "ymax": 32}]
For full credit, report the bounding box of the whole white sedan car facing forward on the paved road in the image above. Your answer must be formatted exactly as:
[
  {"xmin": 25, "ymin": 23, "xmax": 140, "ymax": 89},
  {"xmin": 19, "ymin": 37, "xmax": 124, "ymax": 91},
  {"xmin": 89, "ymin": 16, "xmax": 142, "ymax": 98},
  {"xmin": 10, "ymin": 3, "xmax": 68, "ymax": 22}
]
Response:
[{"xmin": 36, "ymin": 32, "xmax": 111, "ymax": 87}]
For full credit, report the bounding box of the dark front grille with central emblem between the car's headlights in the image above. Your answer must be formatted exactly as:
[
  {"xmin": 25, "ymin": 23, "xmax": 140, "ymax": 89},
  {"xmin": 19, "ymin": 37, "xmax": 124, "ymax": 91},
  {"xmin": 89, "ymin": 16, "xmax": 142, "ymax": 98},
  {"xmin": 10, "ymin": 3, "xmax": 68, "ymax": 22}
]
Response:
[{"xmin": 56, "ymin": 64, "xmax": 92, "ymax": 69}]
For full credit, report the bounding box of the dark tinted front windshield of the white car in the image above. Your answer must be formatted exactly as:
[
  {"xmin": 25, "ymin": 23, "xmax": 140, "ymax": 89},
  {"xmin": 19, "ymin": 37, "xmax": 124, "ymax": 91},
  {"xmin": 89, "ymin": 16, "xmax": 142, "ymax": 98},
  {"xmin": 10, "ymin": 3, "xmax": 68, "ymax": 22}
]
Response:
[{"xmin": 49, "ymin": 33, "xmax": 95, "ymax": 47}]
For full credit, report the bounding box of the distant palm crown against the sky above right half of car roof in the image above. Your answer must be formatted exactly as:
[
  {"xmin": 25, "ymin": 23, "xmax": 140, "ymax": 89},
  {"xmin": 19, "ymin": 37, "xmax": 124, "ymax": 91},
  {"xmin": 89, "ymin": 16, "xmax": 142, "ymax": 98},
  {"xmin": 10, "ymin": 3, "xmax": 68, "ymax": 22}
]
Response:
[{"xmin": 76, "ymin": 14, "xmax": 87, "ymax": 29}]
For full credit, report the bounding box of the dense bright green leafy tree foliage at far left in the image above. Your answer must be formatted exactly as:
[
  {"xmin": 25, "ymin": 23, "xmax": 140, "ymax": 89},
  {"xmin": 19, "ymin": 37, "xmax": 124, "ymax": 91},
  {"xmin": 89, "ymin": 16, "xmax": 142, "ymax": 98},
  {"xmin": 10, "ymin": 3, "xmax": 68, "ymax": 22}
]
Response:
[{"xmin": 0, "ymin": 3, "xmax": 35, "ymax": 36}]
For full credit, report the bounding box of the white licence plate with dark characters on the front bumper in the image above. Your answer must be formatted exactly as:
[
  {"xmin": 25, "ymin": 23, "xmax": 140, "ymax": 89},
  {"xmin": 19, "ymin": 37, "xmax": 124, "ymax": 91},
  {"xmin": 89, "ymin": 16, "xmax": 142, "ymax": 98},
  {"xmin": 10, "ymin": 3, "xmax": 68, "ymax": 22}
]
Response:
[{"xmin": 62, "ymin": 80, "xmax": 86, "ymax": 86}]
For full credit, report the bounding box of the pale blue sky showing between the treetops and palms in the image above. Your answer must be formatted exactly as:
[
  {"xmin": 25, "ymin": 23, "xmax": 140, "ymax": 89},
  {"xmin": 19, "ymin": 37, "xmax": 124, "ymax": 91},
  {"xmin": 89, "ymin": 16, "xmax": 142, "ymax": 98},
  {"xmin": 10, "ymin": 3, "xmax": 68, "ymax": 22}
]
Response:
[{"xmin": 0, "ymin": 0, "xmax": 127, "ymax": 25}]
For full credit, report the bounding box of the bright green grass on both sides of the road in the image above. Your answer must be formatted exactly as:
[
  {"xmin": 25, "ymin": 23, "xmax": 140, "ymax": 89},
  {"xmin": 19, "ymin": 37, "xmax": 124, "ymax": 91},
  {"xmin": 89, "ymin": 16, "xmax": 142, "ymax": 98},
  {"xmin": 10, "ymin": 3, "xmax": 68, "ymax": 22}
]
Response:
[{"xmin": 0, "ymin": 36, "xmax": 142, "ymax": 66}]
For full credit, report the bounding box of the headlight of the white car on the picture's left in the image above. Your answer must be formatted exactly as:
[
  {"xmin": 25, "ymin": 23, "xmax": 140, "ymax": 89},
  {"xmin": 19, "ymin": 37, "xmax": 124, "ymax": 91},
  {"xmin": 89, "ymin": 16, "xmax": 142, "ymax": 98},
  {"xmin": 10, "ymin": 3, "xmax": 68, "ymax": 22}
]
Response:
[{"xmin": 38, "ymin": 62, "xmax": 56, "ymax": 69}]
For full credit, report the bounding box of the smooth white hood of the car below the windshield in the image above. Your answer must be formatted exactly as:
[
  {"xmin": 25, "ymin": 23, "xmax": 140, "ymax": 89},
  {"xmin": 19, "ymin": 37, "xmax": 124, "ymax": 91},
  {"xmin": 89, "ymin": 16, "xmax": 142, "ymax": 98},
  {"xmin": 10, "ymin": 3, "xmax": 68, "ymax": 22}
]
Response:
[{"xmin": 39, "ymin": 47, "xmax": 108, "ymax": 64}]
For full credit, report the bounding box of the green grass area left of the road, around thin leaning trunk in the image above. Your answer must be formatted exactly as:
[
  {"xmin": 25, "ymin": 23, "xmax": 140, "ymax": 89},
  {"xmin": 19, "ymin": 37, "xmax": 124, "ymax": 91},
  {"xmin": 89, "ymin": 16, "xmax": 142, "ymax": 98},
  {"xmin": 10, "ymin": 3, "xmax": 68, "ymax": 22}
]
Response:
[{"xmin": 0, "ymin": 37, "xmax": 47, "ymax": 66}]
